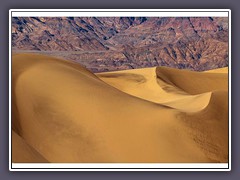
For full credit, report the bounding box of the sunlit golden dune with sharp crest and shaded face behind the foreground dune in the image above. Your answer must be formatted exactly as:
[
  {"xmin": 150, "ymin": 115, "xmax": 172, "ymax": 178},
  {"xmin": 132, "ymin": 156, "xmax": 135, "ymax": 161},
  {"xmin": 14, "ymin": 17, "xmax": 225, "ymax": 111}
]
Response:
[{"xmin": 97, "ymin": 67, "xmax": 228, "ymax": 112}]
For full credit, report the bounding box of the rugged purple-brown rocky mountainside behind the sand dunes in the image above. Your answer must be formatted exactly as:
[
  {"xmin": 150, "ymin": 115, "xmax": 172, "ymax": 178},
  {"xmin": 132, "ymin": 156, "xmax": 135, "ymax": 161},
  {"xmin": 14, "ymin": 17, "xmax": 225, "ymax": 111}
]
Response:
[{"xmin": 12, "ymin": 17, "xmax": 229, "ymax": 72}]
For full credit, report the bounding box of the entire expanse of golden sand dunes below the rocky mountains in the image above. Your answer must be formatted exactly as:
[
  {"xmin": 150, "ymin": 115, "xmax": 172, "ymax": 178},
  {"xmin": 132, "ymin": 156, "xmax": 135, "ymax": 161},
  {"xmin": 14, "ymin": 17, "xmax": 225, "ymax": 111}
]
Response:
[{"xmin": 12, "ymin": 54, "xmax": 228, "ymax": 163}]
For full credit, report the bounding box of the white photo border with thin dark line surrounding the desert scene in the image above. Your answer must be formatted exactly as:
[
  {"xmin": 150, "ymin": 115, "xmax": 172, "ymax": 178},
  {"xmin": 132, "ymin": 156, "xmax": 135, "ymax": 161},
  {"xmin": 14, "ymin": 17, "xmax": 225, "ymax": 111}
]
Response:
[{"xmin": 9, "ymin": 9, "xmax": 231, "ymax": 171}]
